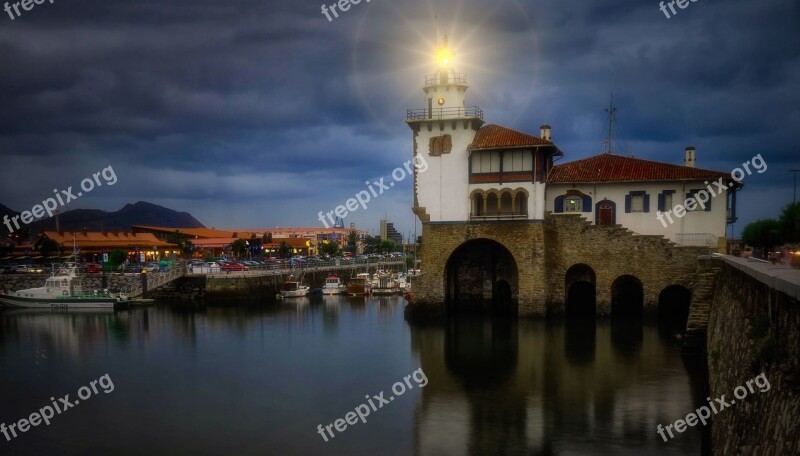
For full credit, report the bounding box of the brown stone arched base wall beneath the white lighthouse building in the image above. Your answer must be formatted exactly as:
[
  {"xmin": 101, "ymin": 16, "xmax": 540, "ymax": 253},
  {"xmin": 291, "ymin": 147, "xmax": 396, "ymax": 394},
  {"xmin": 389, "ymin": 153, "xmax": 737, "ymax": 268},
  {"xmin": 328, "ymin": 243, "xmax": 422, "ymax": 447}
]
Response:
[{"xmin": 408, "ymin": 213, "xmax": 712, "ymax": 317}]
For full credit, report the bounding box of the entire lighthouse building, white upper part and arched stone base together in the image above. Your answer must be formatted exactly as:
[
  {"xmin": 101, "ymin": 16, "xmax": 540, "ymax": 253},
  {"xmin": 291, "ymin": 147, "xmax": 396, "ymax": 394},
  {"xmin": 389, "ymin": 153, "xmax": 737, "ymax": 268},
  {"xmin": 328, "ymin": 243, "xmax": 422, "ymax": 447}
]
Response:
[{"xmin": 406, "ymin": 40, "xmax": 740, "ymax": 316}]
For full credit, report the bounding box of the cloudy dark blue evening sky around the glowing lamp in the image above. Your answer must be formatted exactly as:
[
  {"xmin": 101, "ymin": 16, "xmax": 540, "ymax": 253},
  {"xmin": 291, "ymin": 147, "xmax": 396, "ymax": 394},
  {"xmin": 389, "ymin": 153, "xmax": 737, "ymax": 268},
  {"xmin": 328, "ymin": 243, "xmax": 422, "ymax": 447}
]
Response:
[{"xmin": 0, "ymin": 0, "xmax": 800, "ymax": 235}]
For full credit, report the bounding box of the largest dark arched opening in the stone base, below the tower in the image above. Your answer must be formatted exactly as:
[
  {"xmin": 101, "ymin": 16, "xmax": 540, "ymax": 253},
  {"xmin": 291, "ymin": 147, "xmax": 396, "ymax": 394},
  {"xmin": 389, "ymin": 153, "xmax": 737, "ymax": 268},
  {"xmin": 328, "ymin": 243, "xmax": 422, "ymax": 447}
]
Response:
[{"xmin": 445, "ymin": 239, "xmax": 519, "ymax": 315}]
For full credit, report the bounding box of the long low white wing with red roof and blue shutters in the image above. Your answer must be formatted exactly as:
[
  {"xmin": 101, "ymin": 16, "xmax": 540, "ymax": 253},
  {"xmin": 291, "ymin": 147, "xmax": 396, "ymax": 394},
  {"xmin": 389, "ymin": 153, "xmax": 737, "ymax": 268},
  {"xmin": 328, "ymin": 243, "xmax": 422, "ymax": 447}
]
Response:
[{"xmin": 547, "ymin": 151, "xmax": 741, "ymax": 246}]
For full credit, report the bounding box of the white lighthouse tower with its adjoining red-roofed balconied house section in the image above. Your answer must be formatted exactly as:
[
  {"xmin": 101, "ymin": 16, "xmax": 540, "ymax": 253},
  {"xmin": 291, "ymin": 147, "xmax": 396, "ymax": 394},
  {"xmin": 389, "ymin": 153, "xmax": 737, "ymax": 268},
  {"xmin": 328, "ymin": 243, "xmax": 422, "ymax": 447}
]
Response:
[{"xmin": 406, "ymin": 39, "xmax": 561, "ymax": 223}]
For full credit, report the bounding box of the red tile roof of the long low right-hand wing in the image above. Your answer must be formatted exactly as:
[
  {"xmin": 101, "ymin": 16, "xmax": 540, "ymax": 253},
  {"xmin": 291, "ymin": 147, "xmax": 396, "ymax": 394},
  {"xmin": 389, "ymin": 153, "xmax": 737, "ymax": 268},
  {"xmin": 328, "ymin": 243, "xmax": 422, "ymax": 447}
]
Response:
[{"xmin": 547, "ymin": 153, "xmax": 730, "ymax": 184}]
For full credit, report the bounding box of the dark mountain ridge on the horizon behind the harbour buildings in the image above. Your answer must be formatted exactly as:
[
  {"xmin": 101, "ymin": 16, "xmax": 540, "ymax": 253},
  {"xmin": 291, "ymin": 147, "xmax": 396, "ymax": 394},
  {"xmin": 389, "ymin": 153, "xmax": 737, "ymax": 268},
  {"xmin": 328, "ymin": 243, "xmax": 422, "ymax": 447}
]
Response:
[{"xmin": 23, "ymin": 201, "xmax": 205, "ymax": 233}]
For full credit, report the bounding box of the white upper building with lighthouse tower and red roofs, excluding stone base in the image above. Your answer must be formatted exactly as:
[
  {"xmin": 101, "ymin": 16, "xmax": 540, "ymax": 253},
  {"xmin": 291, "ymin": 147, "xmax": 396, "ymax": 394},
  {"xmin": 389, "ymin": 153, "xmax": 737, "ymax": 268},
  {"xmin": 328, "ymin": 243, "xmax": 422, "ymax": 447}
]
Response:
[{"xmin": 406, "ymin": 40, "xmax": 738, "ymax": 246}]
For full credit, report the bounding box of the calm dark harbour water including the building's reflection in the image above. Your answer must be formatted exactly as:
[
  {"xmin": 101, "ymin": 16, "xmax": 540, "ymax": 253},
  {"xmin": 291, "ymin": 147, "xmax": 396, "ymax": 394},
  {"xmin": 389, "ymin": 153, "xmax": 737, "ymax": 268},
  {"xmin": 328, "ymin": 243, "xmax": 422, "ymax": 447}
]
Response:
[{"xmin": 0, "ymin": 297, "xmax": 702, "ymax": 456}]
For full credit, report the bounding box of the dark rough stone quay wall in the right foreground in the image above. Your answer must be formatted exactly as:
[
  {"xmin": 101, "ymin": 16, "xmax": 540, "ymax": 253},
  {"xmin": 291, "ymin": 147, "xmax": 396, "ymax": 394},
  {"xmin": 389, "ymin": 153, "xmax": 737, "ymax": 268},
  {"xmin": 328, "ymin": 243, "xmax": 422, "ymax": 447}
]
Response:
[{"xmin": 707, "ymin": 260, "xmax": 800, "ymax": 455}]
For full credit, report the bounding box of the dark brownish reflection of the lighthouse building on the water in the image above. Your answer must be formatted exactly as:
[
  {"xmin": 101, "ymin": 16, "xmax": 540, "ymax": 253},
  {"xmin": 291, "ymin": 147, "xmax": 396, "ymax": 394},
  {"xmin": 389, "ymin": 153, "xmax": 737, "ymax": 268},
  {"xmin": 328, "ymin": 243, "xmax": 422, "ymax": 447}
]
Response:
[{"xmin": 411, "ymin": 318, "xmax": 700, "ymax": 455}]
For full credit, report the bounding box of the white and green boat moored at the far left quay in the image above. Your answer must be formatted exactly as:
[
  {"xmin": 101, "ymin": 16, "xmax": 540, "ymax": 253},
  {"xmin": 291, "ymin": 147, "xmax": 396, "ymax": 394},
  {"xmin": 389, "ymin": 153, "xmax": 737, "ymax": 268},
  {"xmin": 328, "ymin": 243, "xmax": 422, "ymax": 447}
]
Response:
[{"xmin": 0, "ymin": 261, "xmax": 131, "ymax": 309}]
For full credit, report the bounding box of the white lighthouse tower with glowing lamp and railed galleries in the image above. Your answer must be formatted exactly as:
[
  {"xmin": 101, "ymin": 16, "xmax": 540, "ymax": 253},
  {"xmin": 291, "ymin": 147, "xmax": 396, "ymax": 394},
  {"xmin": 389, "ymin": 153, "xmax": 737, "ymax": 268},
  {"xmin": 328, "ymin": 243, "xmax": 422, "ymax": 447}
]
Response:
[{"xmin": 406, "ymin": 37, "xmax": 483, "ymax": 223}]
